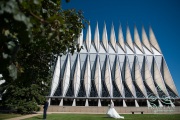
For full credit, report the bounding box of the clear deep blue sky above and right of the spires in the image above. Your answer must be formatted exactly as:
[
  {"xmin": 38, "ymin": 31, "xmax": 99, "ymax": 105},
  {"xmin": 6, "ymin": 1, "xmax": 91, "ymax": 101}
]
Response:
[{"xmin": 62, "ymin": 0, "xmax": 180, "ymax": 94}]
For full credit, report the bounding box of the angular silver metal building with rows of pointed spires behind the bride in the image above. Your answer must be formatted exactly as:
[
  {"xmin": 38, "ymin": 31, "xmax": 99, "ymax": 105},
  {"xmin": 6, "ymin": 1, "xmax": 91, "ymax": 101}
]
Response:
[{"xmin": 48, "ymin": 23, "xmax": 179, "ymax": 107}]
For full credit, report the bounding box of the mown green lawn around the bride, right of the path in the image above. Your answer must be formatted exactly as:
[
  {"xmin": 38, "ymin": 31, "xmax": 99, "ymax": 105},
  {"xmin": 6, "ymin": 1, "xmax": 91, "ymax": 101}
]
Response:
[{"xmin": 23, "ymin": 114, "xmax": 180, "ymax": 120}]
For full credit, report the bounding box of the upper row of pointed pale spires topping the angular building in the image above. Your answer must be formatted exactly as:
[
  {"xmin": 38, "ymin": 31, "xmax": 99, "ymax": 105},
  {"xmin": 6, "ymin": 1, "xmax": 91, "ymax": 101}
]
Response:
[{"xmin": 78, "ymin": 23, "xmax": 161, "ymax": 53}]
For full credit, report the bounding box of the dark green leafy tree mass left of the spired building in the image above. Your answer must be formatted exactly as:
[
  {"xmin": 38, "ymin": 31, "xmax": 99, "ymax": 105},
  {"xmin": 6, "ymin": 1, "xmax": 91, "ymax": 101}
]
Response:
[{"xmin": 0, "ymin": 0, "xmax": 87, "ymax": 113}]
